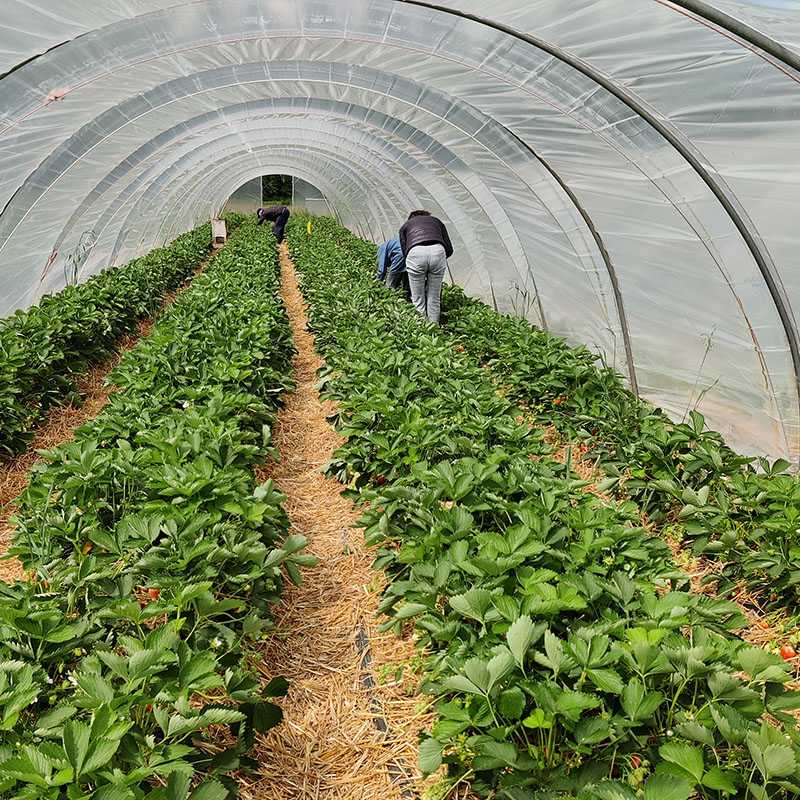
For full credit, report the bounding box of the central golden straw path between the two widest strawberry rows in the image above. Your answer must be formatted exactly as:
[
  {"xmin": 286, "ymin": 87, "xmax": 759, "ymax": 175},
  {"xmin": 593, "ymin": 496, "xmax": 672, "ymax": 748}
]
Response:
[{"xmin": 241, "ymin": 245, "xmax": 428, "ymax": 800}]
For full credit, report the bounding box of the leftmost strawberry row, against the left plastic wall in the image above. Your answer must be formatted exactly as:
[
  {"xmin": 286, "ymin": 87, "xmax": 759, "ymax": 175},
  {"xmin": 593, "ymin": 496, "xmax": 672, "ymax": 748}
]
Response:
[{"xmin": 0, "ymin": 215, "xmax": 243, "ymax": 455}]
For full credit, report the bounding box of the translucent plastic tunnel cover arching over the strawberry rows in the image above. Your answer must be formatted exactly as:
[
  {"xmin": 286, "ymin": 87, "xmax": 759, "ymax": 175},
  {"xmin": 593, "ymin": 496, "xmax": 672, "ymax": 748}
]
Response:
[{"xmin": 0, "ymin": 0, "xmax": 800, "ymax": 461}]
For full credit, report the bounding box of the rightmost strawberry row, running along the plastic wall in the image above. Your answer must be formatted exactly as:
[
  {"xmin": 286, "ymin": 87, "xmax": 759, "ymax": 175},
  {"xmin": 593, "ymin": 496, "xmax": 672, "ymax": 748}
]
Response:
[{"xmin": 444, "ymin": 288, "xmax": 800, "ymax": 608}]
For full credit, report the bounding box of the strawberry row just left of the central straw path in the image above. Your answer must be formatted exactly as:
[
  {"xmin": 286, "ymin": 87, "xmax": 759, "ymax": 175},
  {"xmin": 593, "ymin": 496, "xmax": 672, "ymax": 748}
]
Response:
[{"xmin": 0, "ymin": 220, "xmax": 308, "ymax": 800}]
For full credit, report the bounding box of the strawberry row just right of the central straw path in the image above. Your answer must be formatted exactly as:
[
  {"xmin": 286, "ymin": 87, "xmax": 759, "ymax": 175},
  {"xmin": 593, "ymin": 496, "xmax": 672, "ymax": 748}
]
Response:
[{"xmin": 289, "ymin": 212, "xmax": 800, "ymax": 800}]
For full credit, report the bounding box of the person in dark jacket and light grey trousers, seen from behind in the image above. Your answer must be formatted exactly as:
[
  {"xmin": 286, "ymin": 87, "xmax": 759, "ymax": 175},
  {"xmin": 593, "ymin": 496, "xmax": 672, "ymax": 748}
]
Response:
[{"xmin": 400, "ymin": 211, "xmax": 453, "ymax": 325}]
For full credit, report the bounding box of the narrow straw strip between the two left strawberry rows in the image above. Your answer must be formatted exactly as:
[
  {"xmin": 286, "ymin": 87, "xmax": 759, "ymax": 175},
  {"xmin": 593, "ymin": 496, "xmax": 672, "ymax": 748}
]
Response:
[{"xmin": 0, "ymin": 259, "xmax": 208, "ymax": 583}]
